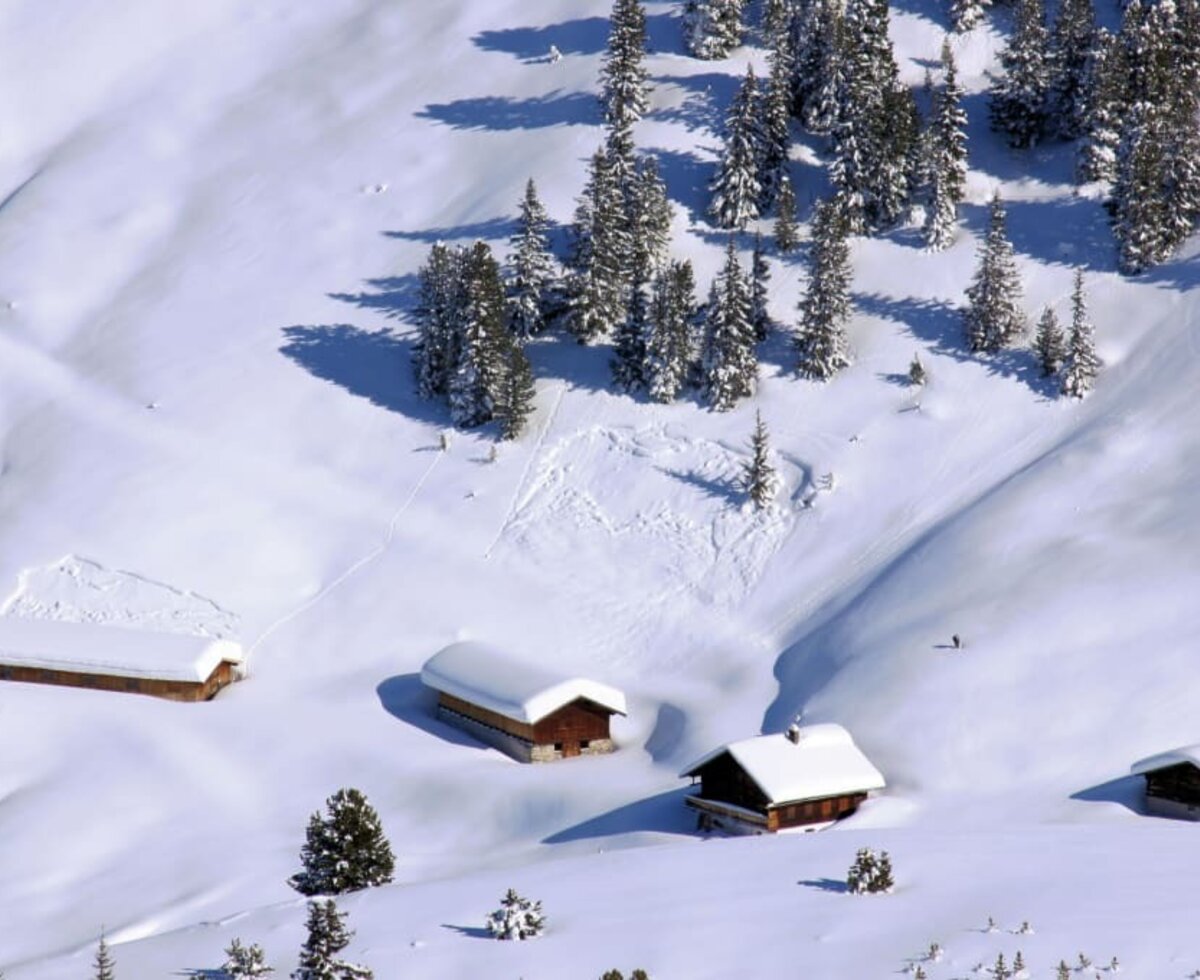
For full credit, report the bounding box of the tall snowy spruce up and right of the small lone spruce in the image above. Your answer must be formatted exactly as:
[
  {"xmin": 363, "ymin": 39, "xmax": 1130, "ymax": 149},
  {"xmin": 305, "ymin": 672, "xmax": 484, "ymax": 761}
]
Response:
[{"xmin": 796, "ymin": 200, "xmax": 851, "ymax": 381}]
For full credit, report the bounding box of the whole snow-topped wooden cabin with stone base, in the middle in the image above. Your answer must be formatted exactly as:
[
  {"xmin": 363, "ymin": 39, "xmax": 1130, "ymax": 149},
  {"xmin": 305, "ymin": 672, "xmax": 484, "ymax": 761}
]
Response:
[{"xmin": 421, "ymin": 643, "xmax": 625, "ymax": 762}]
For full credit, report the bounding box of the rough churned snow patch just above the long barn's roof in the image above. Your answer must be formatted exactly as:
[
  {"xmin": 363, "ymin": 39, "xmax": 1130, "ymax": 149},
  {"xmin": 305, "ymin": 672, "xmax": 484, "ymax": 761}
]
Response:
[{"xmin": 0, "ymin": 554, "xmax": 238, "ymax": 639}]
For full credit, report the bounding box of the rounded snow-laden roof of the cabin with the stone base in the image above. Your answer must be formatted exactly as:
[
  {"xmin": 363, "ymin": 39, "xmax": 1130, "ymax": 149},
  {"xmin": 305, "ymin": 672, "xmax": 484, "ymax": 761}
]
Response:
[{"xmin": 421, "ymin": 642, "xmax": 625, "ymax": 725}]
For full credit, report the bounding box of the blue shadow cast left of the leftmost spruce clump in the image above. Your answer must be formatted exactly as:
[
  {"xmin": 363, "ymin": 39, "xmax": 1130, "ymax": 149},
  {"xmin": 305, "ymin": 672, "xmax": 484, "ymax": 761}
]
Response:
[{"xmin": 280, "ymin": 324, "xmax": 448, "ymax": 425}]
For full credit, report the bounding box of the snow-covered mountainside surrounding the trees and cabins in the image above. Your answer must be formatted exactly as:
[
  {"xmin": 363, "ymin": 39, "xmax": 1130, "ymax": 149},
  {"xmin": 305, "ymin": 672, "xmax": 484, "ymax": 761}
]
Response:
[{"xmin": 0, "ymin": 0, "xmax": 1200, "ymax": 980}]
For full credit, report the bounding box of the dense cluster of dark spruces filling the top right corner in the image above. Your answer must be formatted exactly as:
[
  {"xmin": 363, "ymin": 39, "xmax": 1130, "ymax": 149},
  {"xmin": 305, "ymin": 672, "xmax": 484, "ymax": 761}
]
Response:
[{"xmin": 991, "ymin": 0, "xmax": 1200, "ymax": 272}]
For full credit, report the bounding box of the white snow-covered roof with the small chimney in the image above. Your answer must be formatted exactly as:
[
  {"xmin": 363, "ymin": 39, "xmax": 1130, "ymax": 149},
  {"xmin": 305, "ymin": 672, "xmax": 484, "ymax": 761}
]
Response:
[{"xmin": 680, "ymin": 725, "xmax": 887, "ymax": 804}]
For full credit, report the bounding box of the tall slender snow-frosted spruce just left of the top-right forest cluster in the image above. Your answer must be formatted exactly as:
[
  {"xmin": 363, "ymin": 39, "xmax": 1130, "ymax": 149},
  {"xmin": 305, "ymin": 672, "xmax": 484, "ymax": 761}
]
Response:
[{"xmin": 925, "ymin": 41, "xmax": 967, "ymax": 251}]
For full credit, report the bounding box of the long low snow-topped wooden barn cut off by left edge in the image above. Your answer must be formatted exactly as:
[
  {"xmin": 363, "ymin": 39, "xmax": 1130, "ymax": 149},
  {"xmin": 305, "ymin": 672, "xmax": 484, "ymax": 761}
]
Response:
[{"xmin": 0, "ymin": 615, "xmax": 245, "ymax": 701}]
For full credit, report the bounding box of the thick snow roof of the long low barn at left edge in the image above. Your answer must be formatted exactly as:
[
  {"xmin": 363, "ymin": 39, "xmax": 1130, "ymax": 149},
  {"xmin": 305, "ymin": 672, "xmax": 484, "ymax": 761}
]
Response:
[{"xmin": 0, "ymin": 615, "xmax": 242, "ymax": 681}]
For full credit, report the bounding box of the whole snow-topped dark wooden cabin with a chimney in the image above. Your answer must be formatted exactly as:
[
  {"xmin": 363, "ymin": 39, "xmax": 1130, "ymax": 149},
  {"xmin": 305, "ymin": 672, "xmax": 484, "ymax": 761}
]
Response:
[{"xmin": 680, "ymin": 725, "xmax": 886, "ymax": 834}]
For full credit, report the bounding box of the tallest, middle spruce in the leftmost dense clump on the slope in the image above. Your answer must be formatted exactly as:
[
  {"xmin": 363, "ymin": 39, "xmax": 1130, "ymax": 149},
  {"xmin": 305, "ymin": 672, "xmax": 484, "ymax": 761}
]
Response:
[{"xmin": 448, "ymin": 241, "xmax": 512, "ymax": 428}]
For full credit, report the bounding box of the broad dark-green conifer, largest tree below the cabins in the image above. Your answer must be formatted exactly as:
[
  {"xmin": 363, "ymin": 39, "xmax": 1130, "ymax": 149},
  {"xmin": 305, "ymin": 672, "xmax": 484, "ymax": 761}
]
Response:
[{"xmin": 290, "ymin": 788, "xmax": 395, "ymax": 895}]
